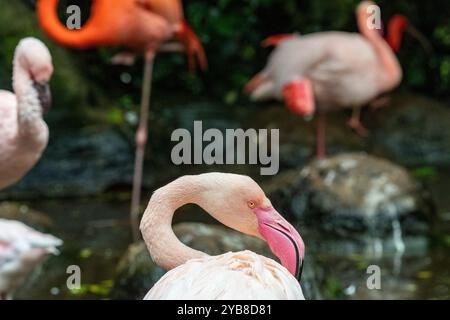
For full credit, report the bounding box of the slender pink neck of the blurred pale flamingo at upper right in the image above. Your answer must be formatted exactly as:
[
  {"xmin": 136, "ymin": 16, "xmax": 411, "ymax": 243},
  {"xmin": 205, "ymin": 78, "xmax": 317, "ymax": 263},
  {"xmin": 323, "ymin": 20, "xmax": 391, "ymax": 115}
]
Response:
[{"xmin": 357, "ymin": 6, "xmax": 403, "ymax": 92}]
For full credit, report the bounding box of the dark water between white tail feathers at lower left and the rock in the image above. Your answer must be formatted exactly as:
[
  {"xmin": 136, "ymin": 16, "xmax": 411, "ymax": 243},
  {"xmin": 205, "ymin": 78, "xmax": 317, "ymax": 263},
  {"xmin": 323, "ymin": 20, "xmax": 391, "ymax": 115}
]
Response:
[{"xmin": 16, "ymin": 199, "xmax": 131, "ymax": 299}]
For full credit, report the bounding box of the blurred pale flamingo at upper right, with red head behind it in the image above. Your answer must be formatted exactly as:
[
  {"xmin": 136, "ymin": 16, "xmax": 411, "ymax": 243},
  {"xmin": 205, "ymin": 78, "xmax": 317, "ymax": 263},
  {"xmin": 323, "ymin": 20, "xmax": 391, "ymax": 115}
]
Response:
[{"xmin": 245, "ymin": 1, "xmax": 424, "ymax": 159}]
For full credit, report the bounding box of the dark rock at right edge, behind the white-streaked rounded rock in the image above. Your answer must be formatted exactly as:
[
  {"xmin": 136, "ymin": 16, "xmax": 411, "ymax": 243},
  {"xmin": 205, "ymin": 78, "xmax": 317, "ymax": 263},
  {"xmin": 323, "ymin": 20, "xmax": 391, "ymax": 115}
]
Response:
[{"xmin": 370, "ymin": 94, "xmax": 450, "ymax": 166}]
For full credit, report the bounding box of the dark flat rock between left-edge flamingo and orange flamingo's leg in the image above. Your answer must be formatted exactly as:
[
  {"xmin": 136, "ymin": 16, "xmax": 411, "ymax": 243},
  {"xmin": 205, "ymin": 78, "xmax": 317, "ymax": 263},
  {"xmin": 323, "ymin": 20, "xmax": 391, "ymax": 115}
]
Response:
[{"xmin": 0, "ymin": 130, "xmax": 133, "ymax": 199}]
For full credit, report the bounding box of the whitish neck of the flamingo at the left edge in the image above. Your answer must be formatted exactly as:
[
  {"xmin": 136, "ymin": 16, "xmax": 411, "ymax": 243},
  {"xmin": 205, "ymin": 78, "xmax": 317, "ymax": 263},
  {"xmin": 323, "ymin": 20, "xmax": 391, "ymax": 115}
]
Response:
[{"xmin": 13, "ymin": 51, "xmax": 48, "ymax": 142}]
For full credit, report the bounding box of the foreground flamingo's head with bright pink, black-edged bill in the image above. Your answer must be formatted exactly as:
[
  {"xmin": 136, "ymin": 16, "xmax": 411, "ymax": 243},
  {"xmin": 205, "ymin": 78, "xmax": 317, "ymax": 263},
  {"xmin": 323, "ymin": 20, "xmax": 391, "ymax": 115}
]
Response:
[{"xmin": 202, "ymin": 173, "xmax": 305, "ymax": 280}]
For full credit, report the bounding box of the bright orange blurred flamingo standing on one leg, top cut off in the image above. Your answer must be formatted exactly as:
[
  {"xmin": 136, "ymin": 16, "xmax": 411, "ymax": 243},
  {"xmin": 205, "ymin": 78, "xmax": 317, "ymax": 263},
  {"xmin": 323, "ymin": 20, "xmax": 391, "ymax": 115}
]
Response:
[{"xmin": 37, "ymin": 0, "xmax": 207, "ymax": 240}]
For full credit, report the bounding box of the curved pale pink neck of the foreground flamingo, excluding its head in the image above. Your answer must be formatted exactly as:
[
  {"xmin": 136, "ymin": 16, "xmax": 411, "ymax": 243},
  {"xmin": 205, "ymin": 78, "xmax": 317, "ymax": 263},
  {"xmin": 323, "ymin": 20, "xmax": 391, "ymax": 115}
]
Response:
[{"xmin": 141, "ymin": 176, "xmax": 206, "ymax": 270}]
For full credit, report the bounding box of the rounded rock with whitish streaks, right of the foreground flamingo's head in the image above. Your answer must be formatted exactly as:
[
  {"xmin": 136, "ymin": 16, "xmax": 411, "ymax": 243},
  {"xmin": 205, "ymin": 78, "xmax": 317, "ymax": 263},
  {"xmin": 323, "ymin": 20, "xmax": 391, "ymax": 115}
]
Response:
[{"xmin": 264, "ymin": 153, "xmax": 431, "ymax": 237}]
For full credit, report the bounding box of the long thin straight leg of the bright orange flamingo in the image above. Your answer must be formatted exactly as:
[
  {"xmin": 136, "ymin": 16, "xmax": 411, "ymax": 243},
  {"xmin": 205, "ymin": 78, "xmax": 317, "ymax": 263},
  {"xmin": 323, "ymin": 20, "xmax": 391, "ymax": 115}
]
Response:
[{"xmin": 131, "ymin": 51, "xmax": 155, "ymax": 241}]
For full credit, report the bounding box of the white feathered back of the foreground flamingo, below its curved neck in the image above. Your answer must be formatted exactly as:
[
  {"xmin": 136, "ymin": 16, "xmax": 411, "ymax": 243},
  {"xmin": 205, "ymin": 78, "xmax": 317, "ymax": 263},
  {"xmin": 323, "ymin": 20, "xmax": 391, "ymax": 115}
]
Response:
[{"xmin": 144, "ymin": 251, "xmax": 305, "ymax": 300}]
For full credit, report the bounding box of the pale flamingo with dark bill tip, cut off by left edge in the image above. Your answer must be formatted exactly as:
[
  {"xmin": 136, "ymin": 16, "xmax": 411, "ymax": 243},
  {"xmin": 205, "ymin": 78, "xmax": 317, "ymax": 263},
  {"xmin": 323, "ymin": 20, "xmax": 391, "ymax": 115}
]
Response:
[{"xmin": 0, "ymin": 38, "xmax": 53, "ymax": 190}]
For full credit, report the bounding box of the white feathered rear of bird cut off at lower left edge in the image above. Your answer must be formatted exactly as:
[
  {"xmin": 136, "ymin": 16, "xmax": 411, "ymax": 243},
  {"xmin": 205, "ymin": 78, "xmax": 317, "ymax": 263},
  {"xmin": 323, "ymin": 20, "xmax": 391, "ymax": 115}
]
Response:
[{"xmin": 0, "ymin": 219, "xmax": 63, "ymax": 300}]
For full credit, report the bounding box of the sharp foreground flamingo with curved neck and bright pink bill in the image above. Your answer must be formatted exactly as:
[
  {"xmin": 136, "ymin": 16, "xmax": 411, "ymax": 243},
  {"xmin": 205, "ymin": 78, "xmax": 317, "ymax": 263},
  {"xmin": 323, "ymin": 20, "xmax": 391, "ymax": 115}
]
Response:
[{"xmin": 141, "ymin": 173, "xmax": 305, "ymax": 300}]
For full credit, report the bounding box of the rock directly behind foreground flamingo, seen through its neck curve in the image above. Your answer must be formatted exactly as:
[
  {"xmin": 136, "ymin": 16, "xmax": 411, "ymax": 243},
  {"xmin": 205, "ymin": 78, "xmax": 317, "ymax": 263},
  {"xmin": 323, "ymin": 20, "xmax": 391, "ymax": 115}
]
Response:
[{"xmin": 111, "ymin": 223, "xmax": 320, "ymax": 299}]
